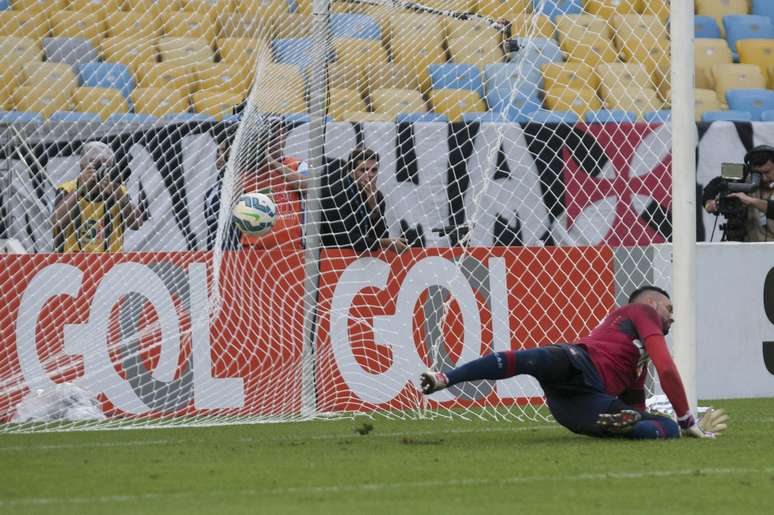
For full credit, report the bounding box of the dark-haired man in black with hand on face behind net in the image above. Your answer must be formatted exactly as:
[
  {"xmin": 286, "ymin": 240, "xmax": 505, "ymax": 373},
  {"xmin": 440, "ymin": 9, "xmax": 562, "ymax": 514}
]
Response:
[{"xmin": 321, "ymin": 148, "xmax": 409, "ymax": 253}]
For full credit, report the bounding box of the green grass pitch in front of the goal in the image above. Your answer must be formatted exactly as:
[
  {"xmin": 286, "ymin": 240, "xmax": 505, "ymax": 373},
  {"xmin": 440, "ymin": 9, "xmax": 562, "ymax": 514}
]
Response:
[{"xmin": 0, "ymin": 398, "xmax": 774, "ymax": 515}]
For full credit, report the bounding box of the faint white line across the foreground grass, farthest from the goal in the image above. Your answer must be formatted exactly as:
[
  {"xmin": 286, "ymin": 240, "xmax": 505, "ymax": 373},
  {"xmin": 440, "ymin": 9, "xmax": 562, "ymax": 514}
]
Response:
[{"xmin": 0, "ymin": 467, "xmax": 774, "ymax": 508}]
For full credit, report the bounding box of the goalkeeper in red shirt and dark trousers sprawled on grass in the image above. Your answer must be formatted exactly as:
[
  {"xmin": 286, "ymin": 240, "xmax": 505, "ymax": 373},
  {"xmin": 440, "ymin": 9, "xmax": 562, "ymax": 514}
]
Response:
[{"xmin": 420, "ymin": 286, "xmax": 728, "ymax": 439}]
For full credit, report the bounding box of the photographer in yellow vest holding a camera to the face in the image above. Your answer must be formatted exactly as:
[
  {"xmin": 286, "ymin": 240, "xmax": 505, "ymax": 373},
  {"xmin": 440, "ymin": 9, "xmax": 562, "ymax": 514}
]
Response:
[{"xmin": 51, "ymin": 141, "xmax": 148, "ymax": 252}]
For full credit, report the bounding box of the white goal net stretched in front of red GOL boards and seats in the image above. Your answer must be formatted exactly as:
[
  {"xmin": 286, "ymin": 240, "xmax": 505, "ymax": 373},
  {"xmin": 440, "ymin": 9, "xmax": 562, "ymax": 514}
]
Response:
[{"xmin": 0, "ymin": 0, "xmax": 672, "ymax": 431}]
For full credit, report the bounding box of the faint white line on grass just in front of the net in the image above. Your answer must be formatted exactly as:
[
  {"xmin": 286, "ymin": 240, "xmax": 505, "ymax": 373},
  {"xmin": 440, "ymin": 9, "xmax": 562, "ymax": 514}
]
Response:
[{"xmin": 0, "ymin": 424, "xmax": 562, "ymax": 452}]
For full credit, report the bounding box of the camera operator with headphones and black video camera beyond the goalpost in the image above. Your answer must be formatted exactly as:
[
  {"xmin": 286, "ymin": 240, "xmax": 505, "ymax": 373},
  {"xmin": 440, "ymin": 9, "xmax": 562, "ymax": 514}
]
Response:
[{"xmin": 702, "ymin": 145, "xmax": 774, "ymax": 241}]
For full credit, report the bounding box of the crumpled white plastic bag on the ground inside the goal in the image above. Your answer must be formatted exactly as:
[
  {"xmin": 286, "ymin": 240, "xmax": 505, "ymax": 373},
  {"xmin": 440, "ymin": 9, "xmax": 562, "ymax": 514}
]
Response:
[{"xmin": 12, "ymin": 383, "xmax": 105, "ymax": 423}]
